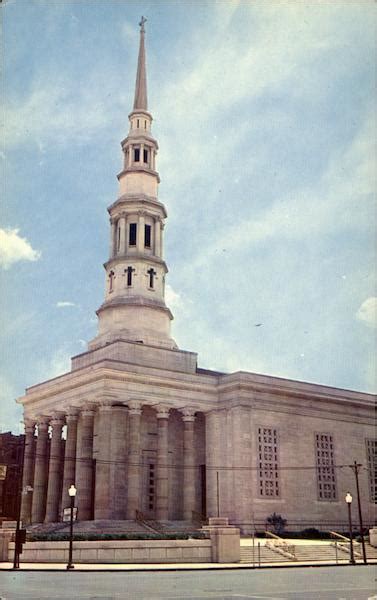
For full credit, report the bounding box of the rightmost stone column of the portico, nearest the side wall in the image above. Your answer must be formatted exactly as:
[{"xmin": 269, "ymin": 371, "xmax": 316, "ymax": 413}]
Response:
[{"xmin": 181, "ymin": 408, "xmax": 197, "ymax": 521}]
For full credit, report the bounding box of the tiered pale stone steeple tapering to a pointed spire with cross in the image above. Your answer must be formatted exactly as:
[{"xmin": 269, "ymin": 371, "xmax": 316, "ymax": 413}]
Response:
[{"xmin": 89, "ymin": 17, "xmax": 177, "ymax": 349}]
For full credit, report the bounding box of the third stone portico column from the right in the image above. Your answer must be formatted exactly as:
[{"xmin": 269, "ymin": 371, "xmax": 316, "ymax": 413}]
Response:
[{"xmin": 127, "ymin": 402, "xmax": 141, "ymax": 519}]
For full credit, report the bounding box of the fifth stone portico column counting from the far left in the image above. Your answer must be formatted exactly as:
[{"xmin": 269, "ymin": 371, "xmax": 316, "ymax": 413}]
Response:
[{"xmin": 76, "ymin": 408, "xmax": 94, "ymax": 521}]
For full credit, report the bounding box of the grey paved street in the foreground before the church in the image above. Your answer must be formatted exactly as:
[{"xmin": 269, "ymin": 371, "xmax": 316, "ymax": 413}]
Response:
[{"xmin": 0, "ymin": 566, "xmax": 377, "ymax": 600}]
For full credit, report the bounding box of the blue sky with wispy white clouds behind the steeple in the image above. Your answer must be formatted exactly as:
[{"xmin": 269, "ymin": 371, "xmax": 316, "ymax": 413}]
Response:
[{"xmin": 0, "ymin": 0, "xmax": 377, "ymax": 433}]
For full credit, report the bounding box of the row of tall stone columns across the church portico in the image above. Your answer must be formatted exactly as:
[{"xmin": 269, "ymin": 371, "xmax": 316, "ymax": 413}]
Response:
[{"xmin": 21, "ymin": 399, "xmax": 198, "ymax": 524}]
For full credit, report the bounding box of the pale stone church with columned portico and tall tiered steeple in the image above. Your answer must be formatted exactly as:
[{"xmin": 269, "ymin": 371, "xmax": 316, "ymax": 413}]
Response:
[{"xmin": 18, "ymin": 19, "xmax": 377, "ymax": 531}]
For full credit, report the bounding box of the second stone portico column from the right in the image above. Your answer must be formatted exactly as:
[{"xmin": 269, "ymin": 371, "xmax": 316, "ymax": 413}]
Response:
[{"xmin": 156, "ymin": 406, "xmax": 170, "ymax": 521}]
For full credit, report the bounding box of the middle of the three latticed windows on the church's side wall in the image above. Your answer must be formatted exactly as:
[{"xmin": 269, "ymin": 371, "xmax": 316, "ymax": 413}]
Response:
[{"xmin": 315, "ymin": 433, "xmax": 337, "ymax": 501}]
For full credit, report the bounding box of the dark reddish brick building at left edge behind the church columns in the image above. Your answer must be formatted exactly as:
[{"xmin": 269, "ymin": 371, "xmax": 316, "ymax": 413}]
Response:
[{"xmin": 0, "ymin": 432, "xmax": 25, "ymax": 519}]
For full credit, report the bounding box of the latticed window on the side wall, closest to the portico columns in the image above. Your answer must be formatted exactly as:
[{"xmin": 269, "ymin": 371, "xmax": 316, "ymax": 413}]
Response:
[{"xmin": 258, "ymin": 427, "xmax": 280, "ymax": 498}]
